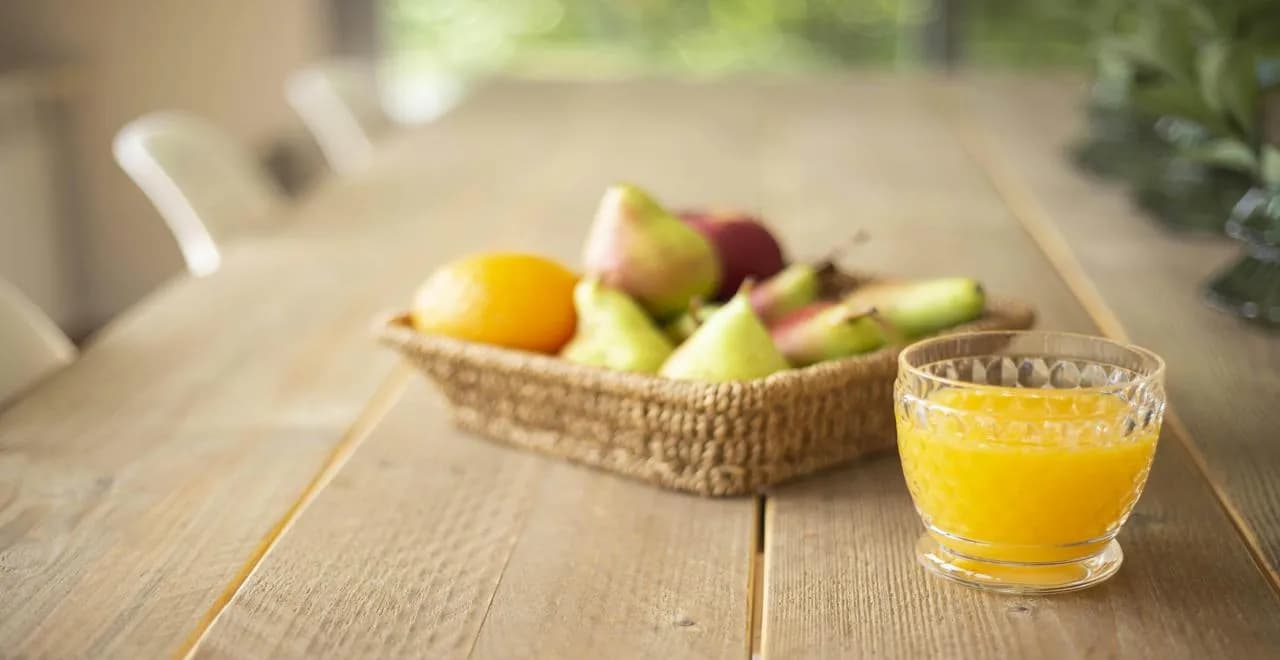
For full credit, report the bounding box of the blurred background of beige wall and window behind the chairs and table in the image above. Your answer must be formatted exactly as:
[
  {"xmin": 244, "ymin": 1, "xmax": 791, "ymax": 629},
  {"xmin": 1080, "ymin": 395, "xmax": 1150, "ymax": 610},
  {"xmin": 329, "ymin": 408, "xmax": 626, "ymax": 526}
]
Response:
[{"xmin": 0, "ymin": 0, "xmax": 1264, "ymax": 339}]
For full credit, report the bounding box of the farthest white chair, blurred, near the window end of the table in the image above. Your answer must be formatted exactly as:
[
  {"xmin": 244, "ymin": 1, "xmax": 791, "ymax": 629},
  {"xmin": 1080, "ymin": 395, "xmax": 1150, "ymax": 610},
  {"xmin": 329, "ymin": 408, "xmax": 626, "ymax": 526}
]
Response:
[{"xmin": 284, "ymin": 60, "xmax": 394, "ymax": 174}]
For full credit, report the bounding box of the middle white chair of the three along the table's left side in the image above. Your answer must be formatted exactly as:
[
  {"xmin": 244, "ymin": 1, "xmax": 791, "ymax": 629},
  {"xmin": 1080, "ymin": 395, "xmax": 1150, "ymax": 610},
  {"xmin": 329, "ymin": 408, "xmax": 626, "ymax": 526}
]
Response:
[{"xmin": 113, "ymin": 111, "xmax": 284, "ymax": 276}]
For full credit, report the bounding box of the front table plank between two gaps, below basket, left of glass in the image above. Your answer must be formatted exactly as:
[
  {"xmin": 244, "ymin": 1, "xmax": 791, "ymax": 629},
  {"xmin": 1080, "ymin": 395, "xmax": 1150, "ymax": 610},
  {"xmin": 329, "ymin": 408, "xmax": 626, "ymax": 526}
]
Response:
[{"xmin": 196, "ymin": 379, "xmax": 755, "ymax": 657}]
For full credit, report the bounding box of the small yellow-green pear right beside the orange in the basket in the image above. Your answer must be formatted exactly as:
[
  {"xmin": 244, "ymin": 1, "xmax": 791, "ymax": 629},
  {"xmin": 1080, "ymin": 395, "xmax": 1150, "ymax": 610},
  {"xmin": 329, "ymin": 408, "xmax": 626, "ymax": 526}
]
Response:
[{"xmin": 561, "ymin": 278, "xmax": 672, "ymax": 373}]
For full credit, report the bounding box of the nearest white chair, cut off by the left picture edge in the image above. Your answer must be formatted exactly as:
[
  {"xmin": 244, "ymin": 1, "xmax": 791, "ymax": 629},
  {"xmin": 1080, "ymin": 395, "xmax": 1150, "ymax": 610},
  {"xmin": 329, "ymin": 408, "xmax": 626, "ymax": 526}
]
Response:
[{"xmin": 0, "ymin": 279, "xmax": 76, "ymax": 408}]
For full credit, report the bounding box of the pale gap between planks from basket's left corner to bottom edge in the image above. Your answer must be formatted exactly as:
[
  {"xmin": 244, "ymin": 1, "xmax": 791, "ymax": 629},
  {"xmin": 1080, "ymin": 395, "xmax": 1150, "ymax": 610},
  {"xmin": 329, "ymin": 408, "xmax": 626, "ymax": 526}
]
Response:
[{"xmin": 173, "ymin": 362, "xmax": 413, "ymax": 660}]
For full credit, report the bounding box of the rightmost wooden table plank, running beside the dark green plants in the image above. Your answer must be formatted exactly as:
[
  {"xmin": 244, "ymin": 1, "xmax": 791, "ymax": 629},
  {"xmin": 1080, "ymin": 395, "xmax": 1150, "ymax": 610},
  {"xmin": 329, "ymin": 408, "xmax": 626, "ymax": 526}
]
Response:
[{"xmin": 954, "ymin": 74, "xmax": 1280, "ymax": 585}]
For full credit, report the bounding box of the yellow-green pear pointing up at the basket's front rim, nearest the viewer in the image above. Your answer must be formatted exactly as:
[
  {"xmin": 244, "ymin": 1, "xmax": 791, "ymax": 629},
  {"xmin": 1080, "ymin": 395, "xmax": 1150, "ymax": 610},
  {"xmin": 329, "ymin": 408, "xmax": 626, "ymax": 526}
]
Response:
[{"xmin": 659, "ymin": 280, "xmax": 791, "ymax": 382}]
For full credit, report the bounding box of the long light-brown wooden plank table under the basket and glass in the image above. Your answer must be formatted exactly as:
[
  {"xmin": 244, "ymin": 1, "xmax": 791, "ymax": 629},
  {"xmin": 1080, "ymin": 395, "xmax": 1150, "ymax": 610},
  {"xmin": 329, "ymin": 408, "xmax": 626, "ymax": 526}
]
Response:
[{"xmin": 0, "ymin": 75, "xmax": 1280, "ymax": 659}]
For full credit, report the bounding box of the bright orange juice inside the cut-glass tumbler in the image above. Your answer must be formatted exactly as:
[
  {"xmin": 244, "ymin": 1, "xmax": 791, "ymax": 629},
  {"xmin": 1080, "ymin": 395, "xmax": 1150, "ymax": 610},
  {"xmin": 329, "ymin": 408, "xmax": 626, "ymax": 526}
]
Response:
[{"xmin": 899, "ymin": 386, "xmax": 1158, "ymax": 563}]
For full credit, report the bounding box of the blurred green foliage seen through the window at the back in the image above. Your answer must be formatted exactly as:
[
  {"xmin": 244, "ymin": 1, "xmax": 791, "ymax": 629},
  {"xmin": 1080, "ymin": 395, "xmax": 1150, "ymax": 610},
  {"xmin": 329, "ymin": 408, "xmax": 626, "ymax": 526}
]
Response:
[{"xmin": 384, "ymin": 0, "xmax": 1088, "ymax": 75}]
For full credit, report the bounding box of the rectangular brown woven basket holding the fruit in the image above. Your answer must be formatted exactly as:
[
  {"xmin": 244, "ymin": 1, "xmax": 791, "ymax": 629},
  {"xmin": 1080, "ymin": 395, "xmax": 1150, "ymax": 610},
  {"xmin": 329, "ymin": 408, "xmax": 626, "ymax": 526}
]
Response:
[{"xmin": 376, "ymin": 272, "xmax": 1034, "ymax": 495}]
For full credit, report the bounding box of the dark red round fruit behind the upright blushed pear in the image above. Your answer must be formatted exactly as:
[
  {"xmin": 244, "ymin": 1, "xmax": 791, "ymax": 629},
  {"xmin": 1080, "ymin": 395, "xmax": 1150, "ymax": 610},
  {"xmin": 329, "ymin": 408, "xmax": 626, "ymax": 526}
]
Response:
[{"xmin": 680, "ymin": 211, "xmax": 786, "ymax": 301}]
